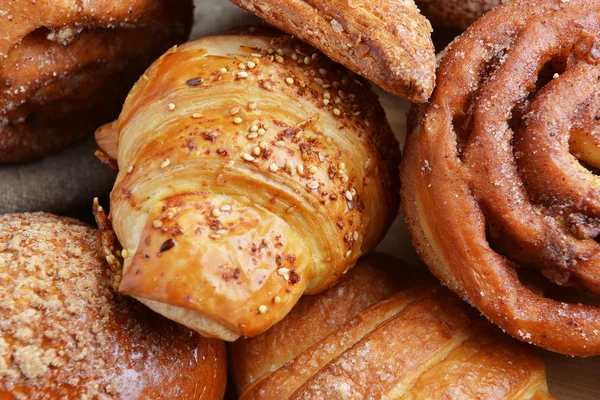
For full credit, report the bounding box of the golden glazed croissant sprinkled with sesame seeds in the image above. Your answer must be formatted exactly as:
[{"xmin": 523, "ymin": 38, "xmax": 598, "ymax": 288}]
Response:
[{"xmin": 97, "ymin": 31, "xmax": 399, "ymax": 340}]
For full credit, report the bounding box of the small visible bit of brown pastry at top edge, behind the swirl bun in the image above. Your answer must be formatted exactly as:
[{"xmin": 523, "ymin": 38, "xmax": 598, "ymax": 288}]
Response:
[{"xmin": 415, "ymin": 0, "xmax": 508, "ymax": 29}]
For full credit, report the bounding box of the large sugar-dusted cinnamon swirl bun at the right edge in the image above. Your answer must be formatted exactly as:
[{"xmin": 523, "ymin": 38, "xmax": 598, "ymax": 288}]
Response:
[{"xmin": 402, "ymin": 0, "xmax": 600, "ymax": 355}]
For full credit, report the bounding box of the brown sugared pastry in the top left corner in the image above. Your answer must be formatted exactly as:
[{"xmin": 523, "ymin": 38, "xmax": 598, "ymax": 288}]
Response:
[{"xmin": 0, "ymin": 0, "xmax": 193, "ymax": 163}]
